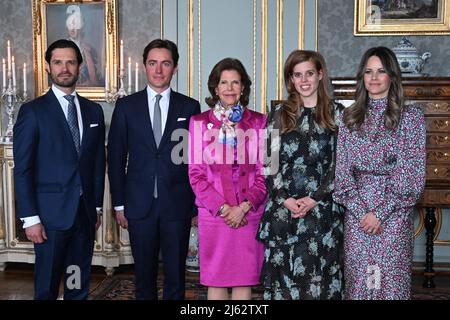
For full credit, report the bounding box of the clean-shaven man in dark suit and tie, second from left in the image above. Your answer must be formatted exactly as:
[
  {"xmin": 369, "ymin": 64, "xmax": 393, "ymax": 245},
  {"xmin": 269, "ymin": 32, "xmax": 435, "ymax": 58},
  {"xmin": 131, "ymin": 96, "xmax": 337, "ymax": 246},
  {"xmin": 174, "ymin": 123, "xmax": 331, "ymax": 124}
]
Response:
[{"xmin": 108, "ymin": 39, "xmax": 200, "ymax": 300}]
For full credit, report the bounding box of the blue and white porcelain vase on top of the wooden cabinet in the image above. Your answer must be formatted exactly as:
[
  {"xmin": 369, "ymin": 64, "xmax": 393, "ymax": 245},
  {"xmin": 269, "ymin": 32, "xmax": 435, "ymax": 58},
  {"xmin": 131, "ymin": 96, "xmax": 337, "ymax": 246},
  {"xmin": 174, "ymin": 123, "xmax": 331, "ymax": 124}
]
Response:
[{"xmin": 392, "ymin": 37, "xmax": 431, "ymax": 76}]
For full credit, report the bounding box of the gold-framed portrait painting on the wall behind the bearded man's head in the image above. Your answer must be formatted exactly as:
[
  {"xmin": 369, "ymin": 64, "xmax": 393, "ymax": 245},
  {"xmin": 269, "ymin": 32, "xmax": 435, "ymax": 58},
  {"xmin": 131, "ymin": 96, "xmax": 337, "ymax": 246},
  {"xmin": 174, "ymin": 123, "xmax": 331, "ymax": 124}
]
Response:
[{"xmin": 31, "ymin": 0, "xmax": 118, "ymax": 101}]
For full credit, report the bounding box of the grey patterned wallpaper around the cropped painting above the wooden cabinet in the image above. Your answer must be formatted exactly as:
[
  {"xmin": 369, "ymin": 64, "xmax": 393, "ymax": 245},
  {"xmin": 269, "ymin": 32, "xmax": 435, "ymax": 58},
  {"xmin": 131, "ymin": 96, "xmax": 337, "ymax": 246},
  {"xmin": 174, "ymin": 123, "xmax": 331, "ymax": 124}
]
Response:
[{"xmin": 318, "ymin": 0, "xmax": 450, "ymax": 77}]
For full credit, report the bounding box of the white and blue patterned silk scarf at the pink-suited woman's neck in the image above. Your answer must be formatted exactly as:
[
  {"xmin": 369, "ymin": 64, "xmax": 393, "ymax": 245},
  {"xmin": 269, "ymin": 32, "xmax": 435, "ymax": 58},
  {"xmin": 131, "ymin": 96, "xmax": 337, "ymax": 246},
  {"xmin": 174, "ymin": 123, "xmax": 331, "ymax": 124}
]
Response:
[{"xmin": 214, "ymin": 101, "xmax": 244, "ymax": 146}]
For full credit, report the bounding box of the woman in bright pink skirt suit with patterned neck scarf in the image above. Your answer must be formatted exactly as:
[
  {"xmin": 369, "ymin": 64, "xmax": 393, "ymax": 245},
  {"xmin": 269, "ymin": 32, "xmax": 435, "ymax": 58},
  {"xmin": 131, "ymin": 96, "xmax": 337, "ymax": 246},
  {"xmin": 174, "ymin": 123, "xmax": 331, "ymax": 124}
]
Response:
[{"xmin": 189, "ymin": 58, "xmax": 267, "ymax": 300}]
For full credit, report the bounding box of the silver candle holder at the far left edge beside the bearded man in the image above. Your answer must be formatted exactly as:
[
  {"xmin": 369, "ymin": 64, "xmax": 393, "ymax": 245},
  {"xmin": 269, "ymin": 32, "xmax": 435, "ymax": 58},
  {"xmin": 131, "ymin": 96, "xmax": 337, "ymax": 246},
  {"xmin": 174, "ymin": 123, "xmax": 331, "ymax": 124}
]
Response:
[{"xmin": 0, "ymin": 71, "xmax": 28, "ymax": 144}]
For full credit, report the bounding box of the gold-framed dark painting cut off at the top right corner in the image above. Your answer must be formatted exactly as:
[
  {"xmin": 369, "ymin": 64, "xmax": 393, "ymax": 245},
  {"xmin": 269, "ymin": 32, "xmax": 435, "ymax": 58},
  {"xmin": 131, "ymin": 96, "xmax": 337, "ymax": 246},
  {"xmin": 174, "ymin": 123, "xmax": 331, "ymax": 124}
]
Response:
[{"xmin": 354, "ymin": 0, "xmax": 450, "ymax": 36}]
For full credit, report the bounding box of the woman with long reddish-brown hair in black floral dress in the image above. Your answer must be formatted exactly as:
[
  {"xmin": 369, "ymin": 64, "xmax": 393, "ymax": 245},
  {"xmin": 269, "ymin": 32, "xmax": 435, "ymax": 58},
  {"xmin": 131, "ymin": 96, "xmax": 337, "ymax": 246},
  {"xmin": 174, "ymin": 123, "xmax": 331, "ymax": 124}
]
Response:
[{"xmin": 257, "ymin": 50, "xmax": 344, "ymax": 300}]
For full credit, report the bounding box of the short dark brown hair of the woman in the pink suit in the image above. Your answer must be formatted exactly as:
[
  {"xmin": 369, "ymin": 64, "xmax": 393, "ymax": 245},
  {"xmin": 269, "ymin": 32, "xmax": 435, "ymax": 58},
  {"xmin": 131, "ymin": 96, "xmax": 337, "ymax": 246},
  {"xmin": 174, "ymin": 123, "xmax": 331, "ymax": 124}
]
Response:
[{"xmin": 205, "ymin": 58, "xmax": 252, "ymax": 108}]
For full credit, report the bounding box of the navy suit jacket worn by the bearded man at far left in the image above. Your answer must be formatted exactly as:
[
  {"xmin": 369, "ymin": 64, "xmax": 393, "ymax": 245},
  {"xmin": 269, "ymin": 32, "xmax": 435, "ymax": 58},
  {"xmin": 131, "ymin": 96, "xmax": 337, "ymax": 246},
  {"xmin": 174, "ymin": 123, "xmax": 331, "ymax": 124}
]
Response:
[{"xmin": 14, "ymin": 90, "xmax": 105, "ymax": 230}]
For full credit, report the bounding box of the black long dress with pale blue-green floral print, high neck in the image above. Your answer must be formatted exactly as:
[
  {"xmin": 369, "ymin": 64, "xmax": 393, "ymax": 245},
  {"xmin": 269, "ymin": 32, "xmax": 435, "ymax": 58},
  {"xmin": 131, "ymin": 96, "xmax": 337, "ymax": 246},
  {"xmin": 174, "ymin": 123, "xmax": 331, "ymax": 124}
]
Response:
[{"xmin": 257, "ymin": 105, "xmax": 344, "ymax": 300}]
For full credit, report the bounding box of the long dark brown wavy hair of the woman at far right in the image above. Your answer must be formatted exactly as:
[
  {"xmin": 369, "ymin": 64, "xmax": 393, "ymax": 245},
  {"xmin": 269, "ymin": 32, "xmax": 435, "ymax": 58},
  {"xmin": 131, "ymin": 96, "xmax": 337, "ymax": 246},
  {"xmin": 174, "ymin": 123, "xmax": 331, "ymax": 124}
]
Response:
[{"xmin": 343, "ymin": 47, "xmax": 403, "ymax": 130}]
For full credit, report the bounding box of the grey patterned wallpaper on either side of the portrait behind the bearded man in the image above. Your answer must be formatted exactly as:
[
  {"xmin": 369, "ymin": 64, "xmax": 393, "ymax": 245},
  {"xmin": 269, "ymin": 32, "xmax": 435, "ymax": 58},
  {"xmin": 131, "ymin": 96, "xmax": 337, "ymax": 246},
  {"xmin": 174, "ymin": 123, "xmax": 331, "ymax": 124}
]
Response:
[{"xmin": 0, "ymin": 0, "xmax": 161, "ymax": 129}]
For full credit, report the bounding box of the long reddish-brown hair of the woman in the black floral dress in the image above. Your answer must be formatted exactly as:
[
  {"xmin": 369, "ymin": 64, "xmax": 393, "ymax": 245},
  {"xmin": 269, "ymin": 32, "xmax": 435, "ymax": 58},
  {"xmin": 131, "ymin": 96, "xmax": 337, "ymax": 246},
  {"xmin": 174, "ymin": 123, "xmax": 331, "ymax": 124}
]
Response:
[{"xmin": 281, "ymin": 50, "xmax": 336, "ymax": 133}]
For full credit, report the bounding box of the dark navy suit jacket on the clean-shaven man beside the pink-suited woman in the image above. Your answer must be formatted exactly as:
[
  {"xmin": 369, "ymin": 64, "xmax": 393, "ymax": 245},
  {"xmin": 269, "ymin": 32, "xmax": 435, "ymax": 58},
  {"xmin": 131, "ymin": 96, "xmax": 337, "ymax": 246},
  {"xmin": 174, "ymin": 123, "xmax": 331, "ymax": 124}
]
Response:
[{"xmin": 108, "ymin": 89, "xmax": 200, "ymax": 220}]
